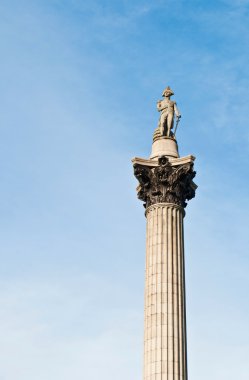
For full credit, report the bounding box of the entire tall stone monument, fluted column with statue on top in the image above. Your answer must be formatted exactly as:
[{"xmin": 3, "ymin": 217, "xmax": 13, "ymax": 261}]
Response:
[{"xmin": 132, "ymin": 87, "xmax": 197, "ymax": 380}]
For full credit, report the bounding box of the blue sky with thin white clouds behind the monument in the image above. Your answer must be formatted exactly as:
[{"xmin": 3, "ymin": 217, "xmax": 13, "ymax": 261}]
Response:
[{"xmin": 0, "ymin": 0, "xmax": 249, "ymax": 380}]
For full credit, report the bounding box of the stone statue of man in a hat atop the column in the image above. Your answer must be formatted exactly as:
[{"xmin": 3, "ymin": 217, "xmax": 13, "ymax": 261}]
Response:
[{"xmin": 157, "ymin": 86, "xmax": 181, "ymax": 137}]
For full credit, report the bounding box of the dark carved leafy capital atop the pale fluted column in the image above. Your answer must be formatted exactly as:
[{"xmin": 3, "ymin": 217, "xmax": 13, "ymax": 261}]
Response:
[{"xmin": 134, "ymin": 156, "xmax": 197, "ymax": 208}]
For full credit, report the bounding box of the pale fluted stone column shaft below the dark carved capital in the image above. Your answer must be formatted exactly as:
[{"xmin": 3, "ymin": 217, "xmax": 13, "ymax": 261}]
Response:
[{"xmin": 144, "ymin": 203, "xmax": 187, "ymax": 380}]
